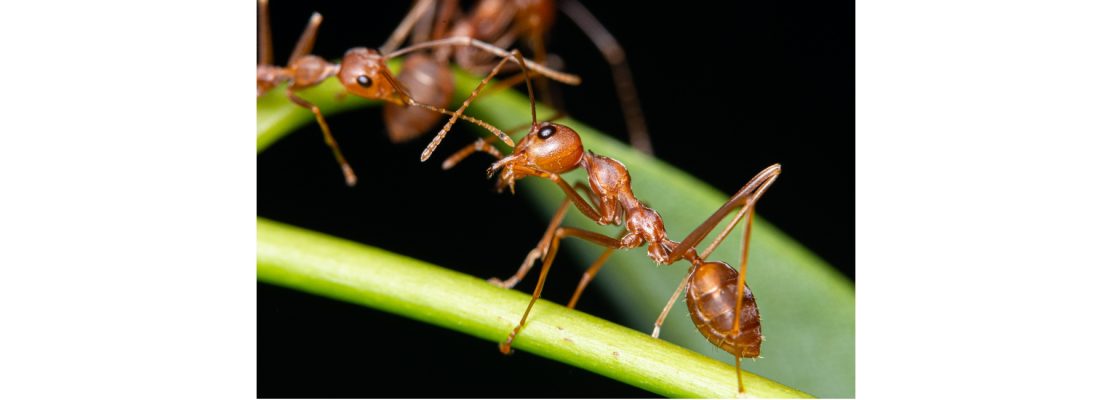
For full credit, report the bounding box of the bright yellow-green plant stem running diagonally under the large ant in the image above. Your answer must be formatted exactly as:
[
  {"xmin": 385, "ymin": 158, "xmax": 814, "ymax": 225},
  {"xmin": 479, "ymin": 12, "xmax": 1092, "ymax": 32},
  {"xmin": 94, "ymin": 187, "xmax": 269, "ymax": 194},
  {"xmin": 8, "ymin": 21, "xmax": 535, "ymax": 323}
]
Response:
[{"xmin": 256, "ymin": 218, "xmax": 809, "ymax": 398}]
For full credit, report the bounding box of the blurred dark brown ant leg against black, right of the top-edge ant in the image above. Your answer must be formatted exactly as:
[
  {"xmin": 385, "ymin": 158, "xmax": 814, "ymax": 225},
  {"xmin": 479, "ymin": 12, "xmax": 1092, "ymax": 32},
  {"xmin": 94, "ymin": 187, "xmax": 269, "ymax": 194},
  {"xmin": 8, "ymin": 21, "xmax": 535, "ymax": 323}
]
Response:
[{"xmin": 560, "ymin": 0, "xmax": 653, "ymax": 155}]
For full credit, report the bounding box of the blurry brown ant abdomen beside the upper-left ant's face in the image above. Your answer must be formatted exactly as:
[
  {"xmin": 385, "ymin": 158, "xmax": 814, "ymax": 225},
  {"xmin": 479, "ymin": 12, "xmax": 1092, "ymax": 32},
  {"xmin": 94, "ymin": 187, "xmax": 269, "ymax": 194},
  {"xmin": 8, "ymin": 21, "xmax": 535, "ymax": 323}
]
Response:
[{"xmin": 385, "ymin": 54, "xmax": 455, "ymax": 143}]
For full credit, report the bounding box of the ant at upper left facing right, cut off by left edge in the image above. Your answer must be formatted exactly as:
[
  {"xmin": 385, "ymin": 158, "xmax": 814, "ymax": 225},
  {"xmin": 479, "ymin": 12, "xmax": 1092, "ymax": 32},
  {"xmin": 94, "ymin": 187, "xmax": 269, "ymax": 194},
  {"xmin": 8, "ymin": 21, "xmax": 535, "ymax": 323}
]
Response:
[{"xmin": 256, "ymin": 0, "xmax": 580, "ymax": 186}]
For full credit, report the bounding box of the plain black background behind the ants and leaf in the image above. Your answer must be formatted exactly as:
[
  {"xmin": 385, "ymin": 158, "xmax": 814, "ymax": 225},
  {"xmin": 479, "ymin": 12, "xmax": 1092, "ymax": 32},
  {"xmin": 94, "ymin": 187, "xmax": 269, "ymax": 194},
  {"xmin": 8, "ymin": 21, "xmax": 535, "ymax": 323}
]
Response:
[{"xmin": 256, "ymin": 1, "xmax": 856, "ymax": 398}]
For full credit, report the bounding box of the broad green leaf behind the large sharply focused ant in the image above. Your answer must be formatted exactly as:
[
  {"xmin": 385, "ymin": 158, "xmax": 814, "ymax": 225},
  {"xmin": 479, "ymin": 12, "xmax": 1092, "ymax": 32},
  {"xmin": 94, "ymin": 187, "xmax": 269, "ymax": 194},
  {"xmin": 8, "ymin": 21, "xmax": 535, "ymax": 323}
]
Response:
[{"xmin": 258, "ymin": 67, "xmax": 855, "ymax": 397}]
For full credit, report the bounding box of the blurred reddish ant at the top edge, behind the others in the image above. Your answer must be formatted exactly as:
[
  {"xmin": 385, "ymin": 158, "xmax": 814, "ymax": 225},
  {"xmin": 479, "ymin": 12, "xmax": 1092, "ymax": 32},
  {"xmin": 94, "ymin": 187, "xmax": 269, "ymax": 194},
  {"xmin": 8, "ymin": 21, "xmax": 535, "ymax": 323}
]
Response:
[{"xmin": 421, "ymin": 0, "xmax": 653, "ymax": 155}]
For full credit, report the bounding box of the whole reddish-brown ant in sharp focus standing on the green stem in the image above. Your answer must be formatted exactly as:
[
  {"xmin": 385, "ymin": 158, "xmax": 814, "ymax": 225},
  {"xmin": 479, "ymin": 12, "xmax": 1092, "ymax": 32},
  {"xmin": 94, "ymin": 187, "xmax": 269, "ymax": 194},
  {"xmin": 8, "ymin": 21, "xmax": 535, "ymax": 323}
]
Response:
[{"xmin": 423, "ymin": 48, "xmax": 782, "ymax": 393}]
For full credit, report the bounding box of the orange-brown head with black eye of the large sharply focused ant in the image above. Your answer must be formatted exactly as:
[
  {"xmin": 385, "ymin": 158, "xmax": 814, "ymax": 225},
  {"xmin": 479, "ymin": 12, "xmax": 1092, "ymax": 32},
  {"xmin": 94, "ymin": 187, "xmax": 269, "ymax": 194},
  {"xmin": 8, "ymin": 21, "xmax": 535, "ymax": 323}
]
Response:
[{"xmin": 513, "ymin": 122, "xmax": 584, "ymax": 174}]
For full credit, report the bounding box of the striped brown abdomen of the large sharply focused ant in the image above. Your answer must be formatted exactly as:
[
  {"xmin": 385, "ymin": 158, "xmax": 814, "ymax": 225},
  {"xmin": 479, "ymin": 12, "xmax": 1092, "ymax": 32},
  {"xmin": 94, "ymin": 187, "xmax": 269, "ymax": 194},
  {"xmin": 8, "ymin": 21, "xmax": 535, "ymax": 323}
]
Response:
[{"xmin": 685, "ymin": 261, "xmax": 763, "ymax": 359}]
